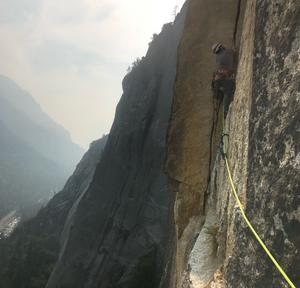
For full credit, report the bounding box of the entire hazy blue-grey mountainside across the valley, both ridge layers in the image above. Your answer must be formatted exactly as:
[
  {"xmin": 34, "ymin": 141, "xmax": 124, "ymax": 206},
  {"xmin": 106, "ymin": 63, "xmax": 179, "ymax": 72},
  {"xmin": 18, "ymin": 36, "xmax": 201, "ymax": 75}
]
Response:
[{"xmin": 0, "ymin": 76, "xmax": 83, "ymax": 217}]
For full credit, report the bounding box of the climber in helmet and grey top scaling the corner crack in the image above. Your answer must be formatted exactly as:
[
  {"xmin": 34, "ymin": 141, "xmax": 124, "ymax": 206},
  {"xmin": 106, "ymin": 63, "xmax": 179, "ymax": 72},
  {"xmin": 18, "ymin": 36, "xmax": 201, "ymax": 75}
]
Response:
[{"xmin": 212, "ymin": 43, "xmax": 236, "ymax": 119}]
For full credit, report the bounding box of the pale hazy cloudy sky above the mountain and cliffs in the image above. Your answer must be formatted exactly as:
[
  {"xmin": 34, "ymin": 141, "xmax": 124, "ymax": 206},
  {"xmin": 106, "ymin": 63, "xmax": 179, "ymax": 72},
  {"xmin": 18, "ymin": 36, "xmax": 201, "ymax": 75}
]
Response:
[{"xmin": 0, "ymin": 0, "xmax": 184, "ymax": 148}]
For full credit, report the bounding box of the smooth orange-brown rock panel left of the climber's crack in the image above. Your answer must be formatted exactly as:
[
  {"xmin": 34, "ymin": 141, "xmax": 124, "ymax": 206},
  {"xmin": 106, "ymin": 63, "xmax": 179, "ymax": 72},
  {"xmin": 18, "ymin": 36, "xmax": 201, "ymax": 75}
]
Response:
[{"xmin": 167, "ymin": 0, "xmax": 244, "ymax": 287}]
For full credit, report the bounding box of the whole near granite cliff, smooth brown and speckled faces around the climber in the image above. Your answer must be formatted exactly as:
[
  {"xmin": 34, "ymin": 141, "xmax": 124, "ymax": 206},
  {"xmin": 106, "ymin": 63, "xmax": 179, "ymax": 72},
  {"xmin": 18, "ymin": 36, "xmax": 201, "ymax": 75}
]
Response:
[{"xmin": 168, "ymin": 0, "xmax": 300, "ymax": 288}]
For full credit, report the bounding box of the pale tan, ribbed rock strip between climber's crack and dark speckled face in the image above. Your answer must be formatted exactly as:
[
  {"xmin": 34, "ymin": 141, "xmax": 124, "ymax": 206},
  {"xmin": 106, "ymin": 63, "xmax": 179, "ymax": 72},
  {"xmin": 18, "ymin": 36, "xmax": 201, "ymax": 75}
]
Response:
[{"xmin": 185, "ymin": 1, "xmax": 256, "ymax": 288}]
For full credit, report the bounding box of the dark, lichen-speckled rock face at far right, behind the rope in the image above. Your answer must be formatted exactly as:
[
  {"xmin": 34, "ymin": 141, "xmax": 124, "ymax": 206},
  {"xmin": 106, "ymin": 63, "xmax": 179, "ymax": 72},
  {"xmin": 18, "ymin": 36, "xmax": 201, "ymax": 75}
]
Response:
[{"xmin": 226, "ymin": 0, "xmax": 300, "ymax": 287}]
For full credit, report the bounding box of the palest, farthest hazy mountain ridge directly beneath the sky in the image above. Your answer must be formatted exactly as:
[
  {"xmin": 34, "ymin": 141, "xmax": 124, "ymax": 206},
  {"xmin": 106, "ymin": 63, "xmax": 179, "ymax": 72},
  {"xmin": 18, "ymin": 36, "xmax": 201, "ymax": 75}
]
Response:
[{"xmin": 0, "ymin": 75, "xmax": 83, "ymax": 170}]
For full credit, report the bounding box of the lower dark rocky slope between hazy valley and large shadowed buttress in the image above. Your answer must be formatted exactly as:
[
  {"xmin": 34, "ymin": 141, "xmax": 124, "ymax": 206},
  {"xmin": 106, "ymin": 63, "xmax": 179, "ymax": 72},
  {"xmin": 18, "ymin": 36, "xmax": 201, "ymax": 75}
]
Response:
[{"xmin": 0, "ymin": 136, "xmax": 107, "ymax": 288}]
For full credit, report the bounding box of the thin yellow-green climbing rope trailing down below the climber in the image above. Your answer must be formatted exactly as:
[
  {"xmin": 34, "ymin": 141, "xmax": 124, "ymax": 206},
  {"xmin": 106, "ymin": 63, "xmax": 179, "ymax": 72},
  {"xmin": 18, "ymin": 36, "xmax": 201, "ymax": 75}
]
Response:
[{"xmin": 221, "ymin": 111, "xmax": 297, "ymax": 288}]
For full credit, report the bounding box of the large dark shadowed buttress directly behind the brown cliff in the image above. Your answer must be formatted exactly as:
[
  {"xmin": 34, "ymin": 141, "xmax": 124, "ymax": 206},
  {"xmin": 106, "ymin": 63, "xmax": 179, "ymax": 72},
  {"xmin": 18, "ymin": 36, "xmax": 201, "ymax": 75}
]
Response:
[{"xmin": 47, "ymin": 6, "xmax": 185, "ymax": 288}]
